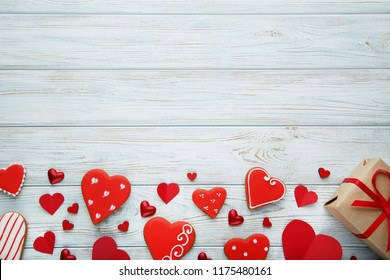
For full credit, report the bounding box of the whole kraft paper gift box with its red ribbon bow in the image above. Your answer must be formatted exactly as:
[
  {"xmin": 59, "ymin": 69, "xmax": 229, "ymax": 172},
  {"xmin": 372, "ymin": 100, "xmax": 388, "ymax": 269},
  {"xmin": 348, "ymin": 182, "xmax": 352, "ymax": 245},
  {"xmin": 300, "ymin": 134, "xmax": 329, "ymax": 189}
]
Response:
[{"xmin": 324, "ymin": 158, "xmax": 390, "ymax": 259}]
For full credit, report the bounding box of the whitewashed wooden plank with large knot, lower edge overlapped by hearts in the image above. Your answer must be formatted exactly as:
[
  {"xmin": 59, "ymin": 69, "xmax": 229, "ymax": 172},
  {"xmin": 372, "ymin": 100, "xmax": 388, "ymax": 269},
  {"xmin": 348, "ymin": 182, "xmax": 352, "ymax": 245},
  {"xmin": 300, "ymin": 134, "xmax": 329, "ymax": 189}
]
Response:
[{"xmin": 0, "ymin": 127, "xmax": 390, "ymax": 185}]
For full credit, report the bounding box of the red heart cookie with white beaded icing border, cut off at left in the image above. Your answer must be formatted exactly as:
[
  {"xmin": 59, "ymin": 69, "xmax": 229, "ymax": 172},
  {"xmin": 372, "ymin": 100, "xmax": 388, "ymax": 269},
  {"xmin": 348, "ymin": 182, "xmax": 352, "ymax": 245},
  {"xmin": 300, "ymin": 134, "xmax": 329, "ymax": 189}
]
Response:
[{"xmin": 0, "ymin": 164, "xmax": 26, "ymax": 196}]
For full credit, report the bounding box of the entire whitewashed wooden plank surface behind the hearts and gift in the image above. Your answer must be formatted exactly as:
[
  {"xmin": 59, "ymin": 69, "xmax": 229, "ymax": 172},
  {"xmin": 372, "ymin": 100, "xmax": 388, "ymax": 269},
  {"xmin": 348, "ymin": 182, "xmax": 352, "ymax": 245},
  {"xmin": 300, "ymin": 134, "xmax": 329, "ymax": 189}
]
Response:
[{"xmin": 0, "ymin": 0, "xmax": 390, "ymax": 259}]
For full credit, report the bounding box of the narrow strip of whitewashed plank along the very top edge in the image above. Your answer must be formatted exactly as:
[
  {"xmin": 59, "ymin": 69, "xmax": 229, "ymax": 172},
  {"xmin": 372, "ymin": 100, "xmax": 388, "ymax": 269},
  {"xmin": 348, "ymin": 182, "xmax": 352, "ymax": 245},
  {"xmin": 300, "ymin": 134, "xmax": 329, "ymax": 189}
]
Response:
[{"xmin": 0, "ymin": 0, "xmax": 390, "ymax": 14}]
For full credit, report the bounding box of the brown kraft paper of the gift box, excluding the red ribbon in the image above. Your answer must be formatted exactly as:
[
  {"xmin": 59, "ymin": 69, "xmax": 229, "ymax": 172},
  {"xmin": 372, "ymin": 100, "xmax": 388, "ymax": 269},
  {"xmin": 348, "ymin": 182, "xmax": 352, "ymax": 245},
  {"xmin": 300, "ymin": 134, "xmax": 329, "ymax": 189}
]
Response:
[{"xmin": 324, "ymin": 158, "xmax": 390, "ymax": 259}]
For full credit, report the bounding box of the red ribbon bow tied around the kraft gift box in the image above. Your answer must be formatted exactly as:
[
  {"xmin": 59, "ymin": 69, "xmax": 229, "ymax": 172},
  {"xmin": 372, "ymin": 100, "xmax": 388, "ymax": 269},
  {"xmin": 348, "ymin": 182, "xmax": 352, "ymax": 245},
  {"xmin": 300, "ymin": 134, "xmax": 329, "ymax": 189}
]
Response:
[{"xmin": 343, "ymin": 169, "xmax": 390, "ymax": 252}]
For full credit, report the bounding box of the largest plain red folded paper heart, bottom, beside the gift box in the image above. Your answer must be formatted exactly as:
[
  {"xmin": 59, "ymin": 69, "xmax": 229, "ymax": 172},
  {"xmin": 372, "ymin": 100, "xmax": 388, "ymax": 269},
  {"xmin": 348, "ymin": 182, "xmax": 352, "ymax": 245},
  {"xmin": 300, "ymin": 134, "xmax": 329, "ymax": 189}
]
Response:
[{"xmin": 282, "ymin": 220, "xmax": 343, "ymax": 260}]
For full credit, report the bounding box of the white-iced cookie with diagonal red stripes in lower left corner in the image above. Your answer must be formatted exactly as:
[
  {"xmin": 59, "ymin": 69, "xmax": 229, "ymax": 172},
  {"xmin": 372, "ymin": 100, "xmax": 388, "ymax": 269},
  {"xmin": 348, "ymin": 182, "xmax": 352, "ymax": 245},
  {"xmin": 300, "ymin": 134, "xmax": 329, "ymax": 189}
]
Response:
[{"xmin": 0, "ymin": 212, "xmax": 27, "ymax": 260}]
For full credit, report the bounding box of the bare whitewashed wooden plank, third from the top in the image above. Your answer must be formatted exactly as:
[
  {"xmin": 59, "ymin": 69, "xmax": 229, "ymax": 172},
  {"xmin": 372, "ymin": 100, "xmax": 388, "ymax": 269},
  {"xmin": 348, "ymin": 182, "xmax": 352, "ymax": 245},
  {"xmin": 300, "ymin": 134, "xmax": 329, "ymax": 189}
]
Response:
[{"xmin": 0, "ymin": 69, "xmax": 390, "ymax": 126}]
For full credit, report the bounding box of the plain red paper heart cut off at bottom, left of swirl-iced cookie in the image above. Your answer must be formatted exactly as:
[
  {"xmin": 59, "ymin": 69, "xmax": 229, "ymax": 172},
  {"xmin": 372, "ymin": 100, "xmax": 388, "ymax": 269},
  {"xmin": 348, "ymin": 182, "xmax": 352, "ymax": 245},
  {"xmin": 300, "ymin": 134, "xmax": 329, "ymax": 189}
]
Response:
[{"xmin": 92, "ymin": 236, "xmax": 130, "ymax": 260}]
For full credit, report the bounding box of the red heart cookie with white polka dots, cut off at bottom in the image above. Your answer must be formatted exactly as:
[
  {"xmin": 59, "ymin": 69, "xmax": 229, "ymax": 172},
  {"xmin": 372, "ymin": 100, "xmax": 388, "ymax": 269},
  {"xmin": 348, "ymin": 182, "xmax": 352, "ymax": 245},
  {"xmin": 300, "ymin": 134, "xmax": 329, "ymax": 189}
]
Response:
[{"xmin": 224, "ymin": 233, "xmax": 270, "ymax": 260}]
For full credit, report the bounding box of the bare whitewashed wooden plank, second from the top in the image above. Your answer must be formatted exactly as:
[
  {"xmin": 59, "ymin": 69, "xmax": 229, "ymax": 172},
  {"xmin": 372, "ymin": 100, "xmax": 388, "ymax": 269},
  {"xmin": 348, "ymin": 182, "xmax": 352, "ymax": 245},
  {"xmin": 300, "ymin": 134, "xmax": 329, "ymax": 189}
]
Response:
[{"xmin": 0, "ymin": 14, "xmax": 390, "ymax": 69}]
